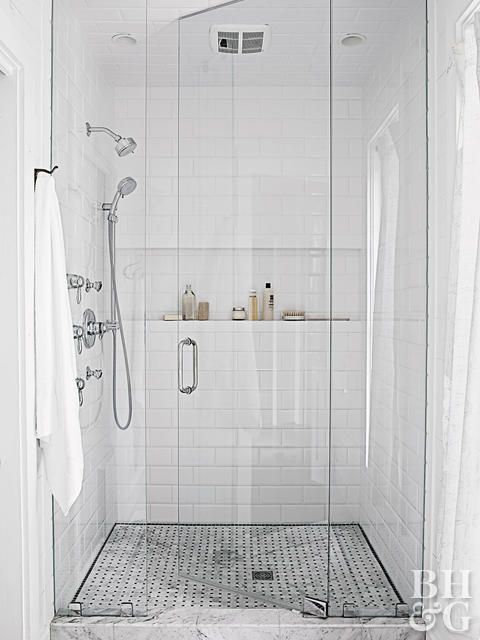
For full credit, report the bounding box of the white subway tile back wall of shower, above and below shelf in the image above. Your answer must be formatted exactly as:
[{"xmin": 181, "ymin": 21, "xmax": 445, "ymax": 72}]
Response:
[{"xmin": 110, "ymin": 81, "xmax": 365, "ymax": 522}]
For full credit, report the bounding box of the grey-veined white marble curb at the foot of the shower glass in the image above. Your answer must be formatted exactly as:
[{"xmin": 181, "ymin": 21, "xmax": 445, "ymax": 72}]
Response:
[{"xmin": 50, "ymin": 608, "xmax": 426, "ymax": 640}]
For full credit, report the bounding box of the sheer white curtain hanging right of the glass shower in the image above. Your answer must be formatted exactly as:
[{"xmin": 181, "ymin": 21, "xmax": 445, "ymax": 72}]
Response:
[{"xmin": 437, "ymin": 16, "xmax": 480, "ymax": 639}]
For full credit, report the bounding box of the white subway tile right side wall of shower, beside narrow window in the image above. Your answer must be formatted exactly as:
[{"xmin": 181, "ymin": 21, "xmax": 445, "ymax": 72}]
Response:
[{"xmin": 361, "ymin": 2, "xmax": 427, "ymax": 598}]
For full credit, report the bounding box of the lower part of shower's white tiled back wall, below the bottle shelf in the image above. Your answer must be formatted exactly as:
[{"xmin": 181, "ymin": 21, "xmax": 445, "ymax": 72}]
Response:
[{"xmin": 147, "ymin": 320, "xmax": 363, "ymax": 522}]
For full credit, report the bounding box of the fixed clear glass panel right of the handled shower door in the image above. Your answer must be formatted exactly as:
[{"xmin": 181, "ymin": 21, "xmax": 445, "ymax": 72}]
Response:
[{"xmin": 329, "ymin": 0, "xmax": 427, "ymax": 617}]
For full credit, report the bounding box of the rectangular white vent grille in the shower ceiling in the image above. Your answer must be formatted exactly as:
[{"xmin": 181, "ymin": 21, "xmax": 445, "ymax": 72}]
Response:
[{"xmin": 210, "ymin": 24, "xmax": 271, "ymax": 55}]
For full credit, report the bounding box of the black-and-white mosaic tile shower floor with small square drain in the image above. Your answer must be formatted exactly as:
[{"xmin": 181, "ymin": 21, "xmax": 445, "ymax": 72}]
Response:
[{"xmin": 73, "ymin": 524, "xmax": 402, "ymax": 616}]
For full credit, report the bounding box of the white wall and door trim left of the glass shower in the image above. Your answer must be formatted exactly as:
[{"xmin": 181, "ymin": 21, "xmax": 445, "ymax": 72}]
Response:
[{"xmin": 0, "ymin": 0, "xmax": 53, "ymax": 640}]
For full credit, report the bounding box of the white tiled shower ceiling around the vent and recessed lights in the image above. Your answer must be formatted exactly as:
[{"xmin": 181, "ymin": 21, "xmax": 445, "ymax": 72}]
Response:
[{"xmin": 69, "ymin": 0, "xmax": 424, "ymax": 86}]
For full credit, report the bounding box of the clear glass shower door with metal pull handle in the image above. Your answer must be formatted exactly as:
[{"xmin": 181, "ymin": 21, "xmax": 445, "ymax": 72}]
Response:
[{"xmin": 177, "ymin": 0, "xmax": 330, "ymax": 615}]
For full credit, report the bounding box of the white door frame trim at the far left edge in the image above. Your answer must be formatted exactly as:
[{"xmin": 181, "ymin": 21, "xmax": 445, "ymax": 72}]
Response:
[{"xmin": 0, "ymin": 42, "xmax": 28, "ymax": 638}]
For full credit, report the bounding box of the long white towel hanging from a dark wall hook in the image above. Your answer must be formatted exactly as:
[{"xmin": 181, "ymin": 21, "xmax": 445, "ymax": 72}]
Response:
[{"xmin": 35, "ymin": 173, "xmax": 83, "ymax": 515}]
